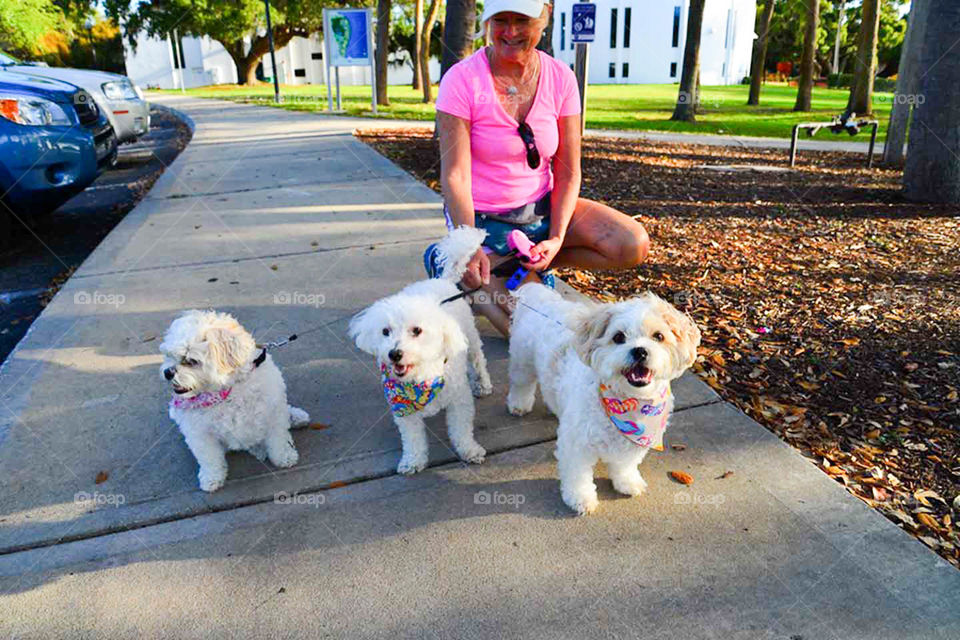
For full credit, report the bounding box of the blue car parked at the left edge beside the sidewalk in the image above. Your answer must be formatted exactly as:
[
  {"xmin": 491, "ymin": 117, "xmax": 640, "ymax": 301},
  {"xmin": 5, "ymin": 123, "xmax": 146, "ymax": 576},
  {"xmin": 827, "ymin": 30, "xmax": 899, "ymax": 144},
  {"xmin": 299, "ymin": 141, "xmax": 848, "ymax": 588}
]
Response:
[{"xmin": 0, "ymin": 69, "xmax": 117, "ymax": 225}]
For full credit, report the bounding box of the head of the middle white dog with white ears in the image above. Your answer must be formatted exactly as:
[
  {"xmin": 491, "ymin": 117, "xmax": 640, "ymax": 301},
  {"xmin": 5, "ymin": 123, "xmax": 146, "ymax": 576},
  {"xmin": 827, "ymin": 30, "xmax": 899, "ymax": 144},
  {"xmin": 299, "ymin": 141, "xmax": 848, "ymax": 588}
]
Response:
[{"xmin": 349, "ymin": 295, "xmax": 467, "ymax": 382}]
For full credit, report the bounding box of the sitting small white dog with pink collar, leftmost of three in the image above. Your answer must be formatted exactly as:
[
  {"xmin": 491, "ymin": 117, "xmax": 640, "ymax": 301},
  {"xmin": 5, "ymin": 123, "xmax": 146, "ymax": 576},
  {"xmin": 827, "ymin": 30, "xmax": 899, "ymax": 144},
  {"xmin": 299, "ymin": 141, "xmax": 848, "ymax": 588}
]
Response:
[{"xmin": 160, "ymin": 310, "xmax": 310, "ymax": 491}]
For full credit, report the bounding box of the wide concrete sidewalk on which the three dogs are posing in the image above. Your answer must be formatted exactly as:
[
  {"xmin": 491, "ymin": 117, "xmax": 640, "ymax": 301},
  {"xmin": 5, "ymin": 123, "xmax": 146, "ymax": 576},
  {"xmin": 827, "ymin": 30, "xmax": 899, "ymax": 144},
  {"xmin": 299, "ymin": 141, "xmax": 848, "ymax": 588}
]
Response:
[{"xmin": 0, "ymin": 97, "xmax": 960, "ymax": 640}]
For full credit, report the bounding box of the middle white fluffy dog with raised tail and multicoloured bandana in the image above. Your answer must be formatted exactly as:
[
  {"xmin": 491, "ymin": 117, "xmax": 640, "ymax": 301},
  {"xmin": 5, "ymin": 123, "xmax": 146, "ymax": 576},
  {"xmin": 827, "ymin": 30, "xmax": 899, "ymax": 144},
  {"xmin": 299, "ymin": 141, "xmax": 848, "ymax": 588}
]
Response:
[{"xmin": 349, "ymin": 227, "xmax": 493, "ymax": 474}]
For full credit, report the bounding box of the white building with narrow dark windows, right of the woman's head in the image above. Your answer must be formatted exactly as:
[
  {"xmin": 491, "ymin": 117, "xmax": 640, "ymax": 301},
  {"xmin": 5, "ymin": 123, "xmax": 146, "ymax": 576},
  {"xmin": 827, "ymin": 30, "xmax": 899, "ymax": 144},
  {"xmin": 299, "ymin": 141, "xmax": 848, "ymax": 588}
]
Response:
[{"xmin": 553, "ymin": 0, "xmax": 757, "ymax": 85}]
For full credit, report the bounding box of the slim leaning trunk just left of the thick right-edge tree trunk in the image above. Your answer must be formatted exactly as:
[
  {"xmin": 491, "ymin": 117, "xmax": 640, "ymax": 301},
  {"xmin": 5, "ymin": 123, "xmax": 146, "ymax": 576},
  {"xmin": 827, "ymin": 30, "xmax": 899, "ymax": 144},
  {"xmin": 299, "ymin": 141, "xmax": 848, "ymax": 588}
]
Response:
[{"xmin": 883, "ymin": 0, "xmax": 930, "ymax": 166}]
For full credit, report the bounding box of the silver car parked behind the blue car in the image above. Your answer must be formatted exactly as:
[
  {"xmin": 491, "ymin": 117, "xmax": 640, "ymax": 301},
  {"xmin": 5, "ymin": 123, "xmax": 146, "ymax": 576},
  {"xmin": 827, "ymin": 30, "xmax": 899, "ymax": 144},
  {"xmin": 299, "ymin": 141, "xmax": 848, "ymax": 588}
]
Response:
[{"xmin": 0, "ymin": 51, "xmax": 150, "ymax": 143}]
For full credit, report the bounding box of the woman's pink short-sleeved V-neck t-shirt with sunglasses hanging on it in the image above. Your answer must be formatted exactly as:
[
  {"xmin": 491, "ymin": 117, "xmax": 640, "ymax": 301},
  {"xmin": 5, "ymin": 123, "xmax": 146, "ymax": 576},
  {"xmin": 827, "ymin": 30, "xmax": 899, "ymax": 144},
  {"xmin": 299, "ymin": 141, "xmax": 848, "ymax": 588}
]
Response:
[{"xmin": 437, "ymin": 49, "xmax": 580, "ymax": 213}]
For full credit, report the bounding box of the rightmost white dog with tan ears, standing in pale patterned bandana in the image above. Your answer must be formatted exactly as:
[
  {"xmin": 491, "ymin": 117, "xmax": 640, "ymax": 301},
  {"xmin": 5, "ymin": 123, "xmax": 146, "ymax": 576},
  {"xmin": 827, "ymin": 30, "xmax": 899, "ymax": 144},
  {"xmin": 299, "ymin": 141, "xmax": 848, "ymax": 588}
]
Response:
[{"xmin": 507, "ymin": 284, "xmax": 700, "ymax": 515}]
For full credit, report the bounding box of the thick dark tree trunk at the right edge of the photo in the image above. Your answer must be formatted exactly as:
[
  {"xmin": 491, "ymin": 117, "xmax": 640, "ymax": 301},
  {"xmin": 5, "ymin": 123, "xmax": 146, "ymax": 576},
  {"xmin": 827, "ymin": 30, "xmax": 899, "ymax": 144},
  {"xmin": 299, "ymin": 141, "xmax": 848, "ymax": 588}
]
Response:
[{"xmin": 903, "ymin": 0, "xmax": 960, "ymax": 204}]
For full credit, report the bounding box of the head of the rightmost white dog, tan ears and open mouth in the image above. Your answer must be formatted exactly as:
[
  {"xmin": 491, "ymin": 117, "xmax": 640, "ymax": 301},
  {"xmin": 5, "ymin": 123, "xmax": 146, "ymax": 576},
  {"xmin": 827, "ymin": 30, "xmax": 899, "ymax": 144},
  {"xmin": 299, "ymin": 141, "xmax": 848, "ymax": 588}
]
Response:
[{"xmin": 575, "ymin": 294, "xmax": 700, "ymax": 396}]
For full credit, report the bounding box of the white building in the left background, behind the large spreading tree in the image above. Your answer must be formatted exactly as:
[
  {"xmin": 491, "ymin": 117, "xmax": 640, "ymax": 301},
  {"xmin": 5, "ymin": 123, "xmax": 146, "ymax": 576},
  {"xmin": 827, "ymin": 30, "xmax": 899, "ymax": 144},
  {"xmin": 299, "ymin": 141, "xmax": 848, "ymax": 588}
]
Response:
[{"xmin": 124, "ymin": 33, "xmax": 440, "ymax": 89}]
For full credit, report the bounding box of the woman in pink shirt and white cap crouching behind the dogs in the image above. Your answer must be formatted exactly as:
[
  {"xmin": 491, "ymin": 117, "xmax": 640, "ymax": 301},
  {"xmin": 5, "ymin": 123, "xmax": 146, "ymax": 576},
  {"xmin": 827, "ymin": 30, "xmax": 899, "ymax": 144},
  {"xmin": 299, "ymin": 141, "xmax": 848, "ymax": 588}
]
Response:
[{"xmin": 425, "ymin": 0, "xmax": 649, "ymax": 335}]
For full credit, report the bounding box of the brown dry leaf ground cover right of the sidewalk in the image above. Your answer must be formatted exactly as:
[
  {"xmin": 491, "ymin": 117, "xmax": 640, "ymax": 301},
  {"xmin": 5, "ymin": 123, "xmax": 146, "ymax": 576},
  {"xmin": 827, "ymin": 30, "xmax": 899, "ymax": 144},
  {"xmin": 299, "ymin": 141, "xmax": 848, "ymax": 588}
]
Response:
[{"xmin": 360, "ymin": 131, "xmax": 960, "ymax": 566}]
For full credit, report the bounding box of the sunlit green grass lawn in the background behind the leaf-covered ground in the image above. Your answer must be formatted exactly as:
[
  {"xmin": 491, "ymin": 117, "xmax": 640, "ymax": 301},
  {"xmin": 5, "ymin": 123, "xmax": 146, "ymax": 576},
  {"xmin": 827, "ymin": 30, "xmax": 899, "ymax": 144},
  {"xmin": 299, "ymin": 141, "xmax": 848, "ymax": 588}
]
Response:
[{"xmin": 154, "ymin": 84, "xmax": 893, "ymax": 140}]
